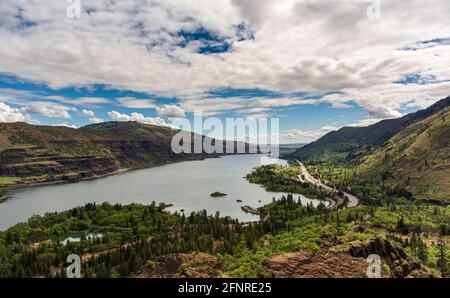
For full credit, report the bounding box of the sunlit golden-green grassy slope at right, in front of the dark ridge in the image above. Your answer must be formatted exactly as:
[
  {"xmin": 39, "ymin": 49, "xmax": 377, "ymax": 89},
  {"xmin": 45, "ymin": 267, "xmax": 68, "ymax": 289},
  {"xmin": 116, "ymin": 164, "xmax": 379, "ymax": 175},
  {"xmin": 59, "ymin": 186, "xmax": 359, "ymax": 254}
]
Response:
[{"xmin": 359, "ymin": 107, "xmax": 450, "ymax": 200}]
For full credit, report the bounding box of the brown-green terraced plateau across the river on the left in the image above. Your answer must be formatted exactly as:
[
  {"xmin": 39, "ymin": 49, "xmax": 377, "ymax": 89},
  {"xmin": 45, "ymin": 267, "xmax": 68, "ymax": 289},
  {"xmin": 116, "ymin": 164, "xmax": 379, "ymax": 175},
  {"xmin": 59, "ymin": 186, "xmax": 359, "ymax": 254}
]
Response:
[{"xmin": 0, "ymin": 122, "xmax": 253, "ymax": 187}]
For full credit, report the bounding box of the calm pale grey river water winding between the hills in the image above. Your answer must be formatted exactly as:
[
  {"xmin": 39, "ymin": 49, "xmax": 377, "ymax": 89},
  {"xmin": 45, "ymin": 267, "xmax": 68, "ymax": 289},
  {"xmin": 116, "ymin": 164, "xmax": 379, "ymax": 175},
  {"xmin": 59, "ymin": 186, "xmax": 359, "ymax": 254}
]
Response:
[{"xmin": 0, "ymin": 155, "xmax": 319, "ymax": 230}]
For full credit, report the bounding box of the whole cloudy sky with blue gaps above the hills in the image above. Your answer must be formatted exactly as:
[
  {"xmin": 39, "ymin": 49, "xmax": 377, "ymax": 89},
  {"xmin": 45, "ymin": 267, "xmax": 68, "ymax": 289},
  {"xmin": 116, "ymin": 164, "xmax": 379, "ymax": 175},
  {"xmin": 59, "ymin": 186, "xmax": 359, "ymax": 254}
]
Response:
[{"xmin": 0, "ymin": 0, "xmax": 450, "ymax": 142}]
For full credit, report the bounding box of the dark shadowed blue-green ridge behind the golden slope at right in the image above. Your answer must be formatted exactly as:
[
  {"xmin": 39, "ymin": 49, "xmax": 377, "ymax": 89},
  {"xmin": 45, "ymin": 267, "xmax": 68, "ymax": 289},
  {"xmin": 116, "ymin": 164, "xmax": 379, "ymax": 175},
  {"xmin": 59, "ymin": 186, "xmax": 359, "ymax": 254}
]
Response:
[{"xmin": 289, "ymin": 96, "xmax": 450, "ymax": 161}]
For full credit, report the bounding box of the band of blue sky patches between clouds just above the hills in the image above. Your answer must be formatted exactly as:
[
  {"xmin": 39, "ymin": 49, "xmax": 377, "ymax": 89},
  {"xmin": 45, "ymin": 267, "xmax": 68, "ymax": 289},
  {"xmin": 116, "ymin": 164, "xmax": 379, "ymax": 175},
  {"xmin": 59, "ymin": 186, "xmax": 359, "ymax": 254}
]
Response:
[{"xmin": 0, "ymin": 75, "xmax": 368, "ymax": 139}]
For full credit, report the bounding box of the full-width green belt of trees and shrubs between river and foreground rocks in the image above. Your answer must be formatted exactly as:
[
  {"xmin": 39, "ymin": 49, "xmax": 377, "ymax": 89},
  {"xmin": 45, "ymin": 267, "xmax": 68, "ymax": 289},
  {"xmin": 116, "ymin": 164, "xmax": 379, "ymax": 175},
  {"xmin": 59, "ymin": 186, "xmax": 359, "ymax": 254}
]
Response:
[{"xmin": 0, "ymin": 195, "xmax": 450, "ymax": 277}]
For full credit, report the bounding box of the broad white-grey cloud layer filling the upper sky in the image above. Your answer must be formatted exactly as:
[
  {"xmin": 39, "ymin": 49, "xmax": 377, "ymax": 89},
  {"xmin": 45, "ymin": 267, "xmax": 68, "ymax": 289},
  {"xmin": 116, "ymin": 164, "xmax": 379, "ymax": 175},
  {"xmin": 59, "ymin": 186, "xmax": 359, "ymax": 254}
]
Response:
[{"xmin": 0, "ymin": 0, "xmax": 450, "ymax": 122}]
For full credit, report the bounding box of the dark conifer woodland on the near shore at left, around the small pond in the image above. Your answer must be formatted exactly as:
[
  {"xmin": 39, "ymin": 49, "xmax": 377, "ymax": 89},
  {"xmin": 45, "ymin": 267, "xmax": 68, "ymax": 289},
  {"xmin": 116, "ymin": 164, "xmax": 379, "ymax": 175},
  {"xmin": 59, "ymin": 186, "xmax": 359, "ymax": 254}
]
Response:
[{"xmin": 0, "ymin": 195, "xmax": 329, "ymax": 277}]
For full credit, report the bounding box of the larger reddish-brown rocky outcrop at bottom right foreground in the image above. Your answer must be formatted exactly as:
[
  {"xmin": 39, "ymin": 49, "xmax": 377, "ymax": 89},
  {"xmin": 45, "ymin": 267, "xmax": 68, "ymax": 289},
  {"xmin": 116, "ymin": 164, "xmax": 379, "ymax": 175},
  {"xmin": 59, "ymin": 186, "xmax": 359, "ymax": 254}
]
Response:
[{"xmin": 263, "ymin": 238, "xmax": 433, "ymax": 278}]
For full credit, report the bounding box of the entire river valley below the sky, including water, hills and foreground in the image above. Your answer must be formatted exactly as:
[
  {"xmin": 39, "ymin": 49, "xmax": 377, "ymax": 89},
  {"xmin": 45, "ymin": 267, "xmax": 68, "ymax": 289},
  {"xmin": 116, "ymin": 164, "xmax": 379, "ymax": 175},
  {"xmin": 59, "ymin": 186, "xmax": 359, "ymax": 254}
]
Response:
[{"xmin": 0, "ymin": 98, "xmax": 450, "ymax": 278}]
